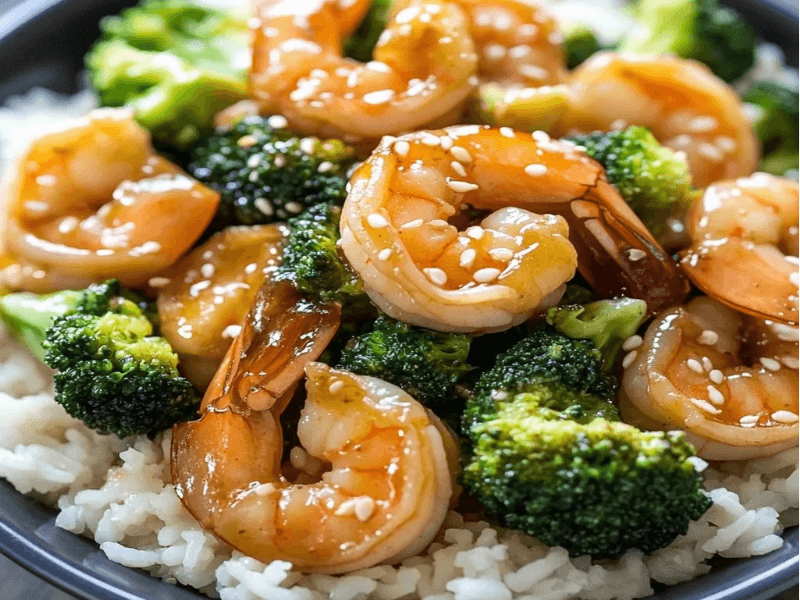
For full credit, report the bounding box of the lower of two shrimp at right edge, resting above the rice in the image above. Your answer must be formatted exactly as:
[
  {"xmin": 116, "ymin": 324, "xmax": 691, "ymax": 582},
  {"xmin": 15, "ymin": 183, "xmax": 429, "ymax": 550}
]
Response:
[{"xmin": 620, "ymin": 297, "xmax": 798, "ymax": 460}]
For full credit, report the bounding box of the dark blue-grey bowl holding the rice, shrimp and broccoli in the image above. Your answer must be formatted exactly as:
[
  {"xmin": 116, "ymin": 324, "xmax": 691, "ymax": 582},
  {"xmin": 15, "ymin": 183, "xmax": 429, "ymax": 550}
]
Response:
[{"xmin": 0, "ymin": 0, "xmax": 798, "ymax": 600}]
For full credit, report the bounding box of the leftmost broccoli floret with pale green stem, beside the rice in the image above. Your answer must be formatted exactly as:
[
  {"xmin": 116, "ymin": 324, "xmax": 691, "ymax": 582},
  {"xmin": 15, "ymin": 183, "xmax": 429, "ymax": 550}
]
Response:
[{"xmin": 0, "ymin": 280, "xmax": 198, "ymax": 437}]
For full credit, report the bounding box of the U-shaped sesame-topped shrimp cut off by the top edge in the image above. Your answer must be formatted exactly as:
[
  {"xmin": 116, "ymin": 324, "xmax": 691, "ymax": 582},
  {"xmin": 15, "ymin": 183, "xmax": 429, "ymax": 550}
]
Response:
[{"xmin": 250, "ymin": 0, "xmax": 477, "ymax": 141}]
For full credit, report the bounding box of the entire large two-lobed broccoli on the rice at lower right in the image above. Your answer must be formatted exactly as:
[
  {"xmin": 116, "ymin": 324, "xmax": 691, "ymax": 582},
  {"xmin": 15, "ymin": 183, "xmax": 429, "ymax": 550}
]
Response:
[{"xmin": 463, "ymin": 329, "xmax": 711, "ymax": 558}]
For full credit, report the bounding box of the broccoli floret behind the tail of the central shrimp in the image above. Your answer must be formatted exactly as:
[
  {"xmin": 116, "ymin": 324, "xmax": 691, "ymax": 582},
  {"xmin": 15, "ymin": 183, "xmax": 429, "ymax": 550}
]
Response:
[{"xmin": 570, "ymin": 125, "xmax": 696, "ymax": 237}]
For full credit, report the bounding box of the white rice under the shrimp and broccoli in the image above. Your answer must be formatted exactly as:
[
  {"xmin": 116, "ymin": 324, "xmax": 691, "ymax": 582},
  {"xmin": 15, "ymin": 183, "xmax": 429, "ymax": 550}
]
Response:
[{"xmin": 0, "ymin": 0, "xmax": 798, "ymax": 600}]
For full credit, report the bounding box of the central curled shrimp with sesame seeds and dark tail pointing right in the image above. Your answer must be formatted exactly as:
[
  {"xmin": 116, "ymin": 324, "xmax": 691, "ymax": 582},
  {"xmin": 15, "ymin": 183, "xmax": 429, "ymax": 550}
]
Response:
[{"xmin": 340, "ymin": 125, "xmax": 688, "ymax": 332}]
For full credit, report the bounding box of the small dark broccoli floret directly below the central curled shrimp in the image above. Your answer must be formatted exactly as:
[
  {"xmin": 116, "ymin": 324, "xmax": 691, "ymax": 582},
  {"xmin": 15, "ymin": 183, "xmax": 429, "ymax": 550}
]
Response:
[{"xmin": 338, "ymin": 317, "xmax": 471, "ymax": 414}]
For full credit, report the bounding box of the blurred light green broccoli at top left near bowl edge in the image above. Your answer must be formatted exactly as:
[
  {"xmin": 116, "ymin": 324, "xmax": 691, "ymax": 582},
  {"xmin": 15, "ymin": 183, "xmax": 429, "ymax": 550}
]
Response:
[{"xmin": 86, "ymin": 0, "xmax": 250, "ymax": 149}]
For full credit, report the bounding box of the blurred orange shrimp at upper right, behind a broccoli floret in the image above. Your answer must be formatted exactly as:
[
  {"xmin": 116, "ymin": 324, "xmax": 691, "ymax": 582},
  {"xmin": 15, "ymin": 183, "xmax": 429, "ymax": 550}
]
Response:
[{"xmin": 554, "ymin": 52, "xmax": 759, "ymax": 187}]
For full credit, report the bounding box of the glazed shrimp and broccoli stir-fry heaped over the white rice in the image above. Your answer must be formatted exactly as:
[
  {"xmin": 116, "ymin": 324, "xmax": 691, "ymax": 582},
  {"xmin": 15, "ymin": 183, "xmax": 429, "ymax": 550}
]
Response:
[{"xmin": 0, "ymin": 0, "xmax": 800, "ymax": 599}]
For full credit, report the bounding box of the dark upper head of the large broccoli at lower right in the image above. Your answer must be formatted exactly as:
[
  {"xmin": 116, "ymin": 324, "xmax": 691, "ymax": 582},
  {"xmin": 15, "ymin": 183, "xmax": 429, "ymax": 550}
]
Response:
[{"xmin": 464, "ymin": 329, "xmax": 619, "ymax": 431}]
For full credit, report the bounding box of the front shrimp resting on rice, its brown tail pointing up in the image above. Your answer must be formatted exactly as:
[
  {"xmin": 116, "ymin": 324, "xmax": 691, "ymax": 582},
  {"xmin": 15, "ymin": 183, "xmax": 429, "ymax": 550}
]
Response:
[{"xmin": 172, "ymin": 282, "xmax": 453, "ymax": 573}]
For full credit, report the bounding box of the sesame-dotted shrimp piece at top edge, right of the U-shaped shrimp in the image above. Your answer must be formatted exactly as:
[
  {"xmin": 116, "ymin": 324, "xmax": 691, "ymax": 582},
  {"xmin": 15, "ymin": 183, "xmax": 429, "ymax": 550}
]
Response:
[{"xmin": 454, "ymin": 0, "xmax": 567, "ymax": 88}]
